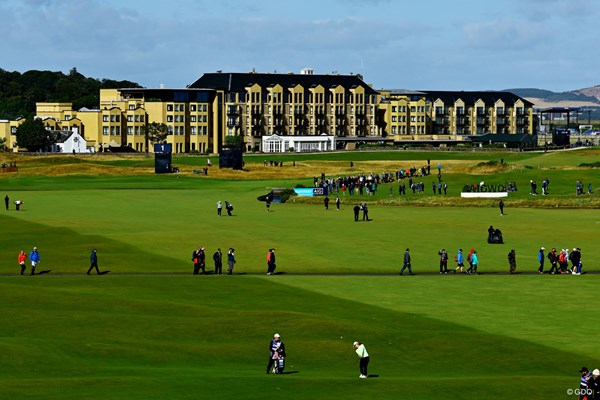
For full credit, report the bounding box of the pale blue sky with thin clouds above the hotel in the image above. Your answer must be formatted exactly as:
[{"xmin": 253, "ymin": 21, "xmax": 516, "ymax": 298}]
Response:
[{"xmin": 0, "ymin": 0, "xmax": 600, "ymax": 92}]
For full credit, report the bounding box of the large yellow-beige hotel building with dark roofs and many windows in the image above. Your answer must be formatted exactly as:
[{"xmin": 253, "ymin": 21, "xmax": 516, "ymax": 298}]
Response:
[{"xmin": 0, "ymin": 69, "xmax": 535, "ymax": 153}]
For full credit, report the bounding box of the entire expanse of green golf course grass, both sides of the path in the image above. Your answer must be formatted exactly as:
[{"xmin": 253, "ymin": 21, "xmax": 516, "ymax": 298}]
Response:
[{"xmin": 0, "ymin": 148, "xmax": 600, "ymax": 399}]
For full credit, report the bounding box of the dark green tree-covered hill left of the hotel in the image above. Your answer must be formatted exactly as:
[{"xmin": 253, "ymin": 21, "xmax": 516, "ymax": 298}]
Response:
[{"xmin": 0, "ymin": 68, "xmax": 141, "ymax": 120}]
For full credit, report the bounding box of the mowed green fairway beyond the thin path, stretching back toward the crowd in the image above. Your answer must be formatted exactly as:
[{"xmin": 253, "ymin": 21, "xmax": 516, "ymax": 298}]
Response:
[{"xmin": 0, "ymin": 176, "xmax": 600, "ymax": 274}]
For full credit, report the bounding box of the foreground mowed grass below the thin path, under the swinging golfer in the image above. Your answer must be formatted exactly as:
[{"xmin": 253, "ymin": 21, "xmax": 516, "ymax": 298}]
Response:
[{"xmin": 0, "ymin": 275, "xmax": 600, "ymax": 399}]
